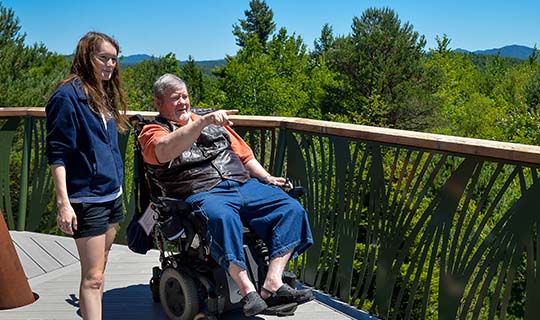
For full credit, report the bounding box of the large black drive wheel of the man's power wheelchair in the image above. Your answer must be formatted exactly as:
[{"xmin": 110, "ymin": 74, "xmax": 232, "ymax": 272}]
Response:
[{"xmin": 159, "ymin": 268, "xmax": 199, "ymax": 320}]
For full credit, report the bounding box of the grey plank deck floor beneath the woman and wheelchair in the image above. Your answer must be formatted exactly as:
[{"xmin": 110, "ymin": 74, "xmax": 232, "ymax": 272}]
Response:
[{"xmin": 0, "ymin": 231, "xmax": 375, "ymax": 320}]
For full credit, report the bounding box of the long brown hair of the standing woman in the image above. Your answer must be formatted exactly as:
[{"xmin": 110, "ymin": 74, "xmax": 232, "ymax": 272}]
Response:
[{"xmin": 62, "ymin": 32, "xmax": 127, "ymax": 132}]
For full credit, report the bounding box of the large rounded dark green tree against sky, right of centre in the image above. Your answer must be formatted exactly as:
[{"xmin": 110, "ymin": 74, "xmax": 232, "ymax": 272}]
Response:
[{"xmin": 352, "ymin": 8, "xmax": 426, "ymax": 126}]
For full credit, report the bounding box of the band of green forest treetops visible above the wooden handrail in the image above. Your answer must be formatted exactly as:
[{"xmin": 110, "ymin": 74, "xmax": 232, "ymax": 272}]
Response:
[{"xmin": 0, "ymin": 0, "xmax": 540, "ymax": 144}]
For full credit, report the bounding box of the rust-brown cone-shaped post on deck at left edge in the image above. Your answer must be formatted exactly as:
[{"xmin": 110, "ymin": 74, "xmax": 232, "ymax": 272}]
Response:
[{"xmin": 0, "ymin": 210, "xmax": 36, "ymax": 310}]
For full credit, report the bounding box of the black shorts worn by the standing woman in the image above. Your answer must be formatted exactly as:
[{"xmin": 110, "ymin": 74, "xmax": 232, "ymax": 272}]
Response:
[{"xmin": 71, "ymin": 197, "xmax": 124, "ymax": 239}]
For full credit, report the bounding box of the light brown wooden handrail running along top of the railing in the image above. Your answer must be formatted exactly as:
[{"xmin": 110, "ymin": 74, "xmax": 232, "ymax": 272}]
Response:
[{"xmin": 0, "ymin": 107, "xmax": 540, "ymax": 164}]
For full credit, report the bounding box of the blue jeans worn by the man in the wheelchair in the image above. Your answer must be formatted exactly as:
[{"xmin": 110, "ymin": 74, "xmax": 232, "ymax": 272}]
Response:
[{"xmin": 186, "ymin": 179, "xmax": 313, "ymax": 270}]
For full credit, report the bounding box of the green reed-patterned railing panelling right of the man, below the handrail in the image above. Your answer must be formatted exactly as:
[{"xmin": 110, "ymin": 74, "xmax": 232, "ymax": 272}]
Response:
[{"xmin": 274, "ymin": 127, "xmax": 540, "ymax": 319}]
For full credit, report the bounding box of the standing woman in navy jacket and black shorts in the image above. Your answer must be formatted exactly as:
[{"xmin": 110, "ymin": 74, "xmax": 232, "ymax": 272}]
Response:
[{"xmin": 45, "ymin": 32, "xmax": 127, "ymax": 319}]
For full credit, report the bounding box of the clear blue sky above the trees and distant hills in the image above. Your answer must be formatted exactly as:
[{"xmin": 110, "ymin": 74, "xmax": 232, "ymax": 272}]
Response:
[{"xmin": 4, "ymin": 0, "xmax": 540, "ymax": 61}]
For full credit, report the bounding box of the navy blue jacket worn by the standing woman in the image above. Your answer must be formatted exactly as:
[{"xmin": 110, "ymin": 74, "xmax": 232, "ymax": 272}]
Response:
[{"xmin": 45, "ymin": 80, "xmax": 124, "ymax": 198}]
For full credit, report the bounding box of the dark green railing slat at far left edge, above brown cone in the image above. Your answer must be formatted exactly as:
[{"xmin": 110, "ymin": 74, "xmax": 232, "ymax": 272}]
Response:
[{"xmin": 0, "ymin": 117, "xmax": 21, "ymax": 229}]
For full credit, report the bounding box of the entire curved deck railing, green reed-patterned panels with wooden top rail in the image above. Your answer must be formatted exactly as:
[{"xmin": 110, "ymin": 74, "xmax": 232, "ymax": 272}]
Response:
[{"xmin": 0, "ymin": 108, "xmax": 540, "ymax": 319}]
